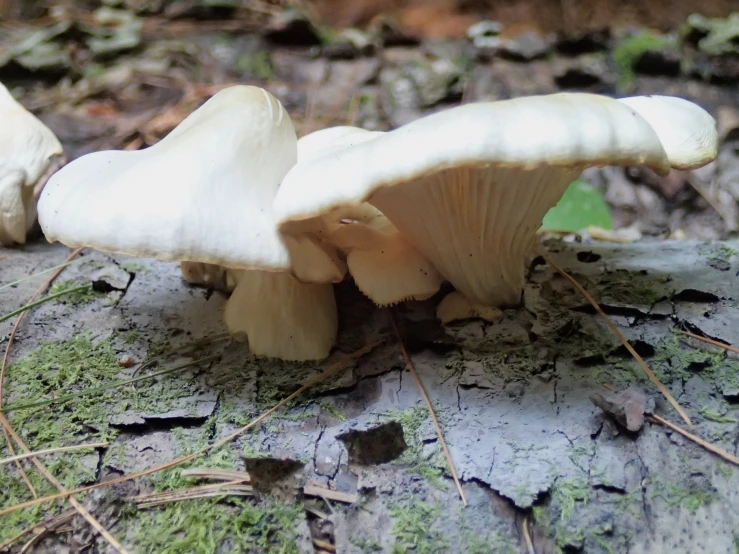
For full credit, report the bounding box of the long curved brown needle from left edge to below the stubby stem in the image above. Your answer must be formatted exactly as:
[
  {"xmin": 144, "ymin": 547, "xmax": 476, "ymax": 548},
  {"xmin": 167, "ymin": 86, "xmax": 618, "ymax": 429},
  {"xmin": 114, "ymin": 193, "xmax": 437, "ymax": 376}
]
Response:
[{"xmin": 0, "ymin": 340, "xmax": 384, "ymax": 516}]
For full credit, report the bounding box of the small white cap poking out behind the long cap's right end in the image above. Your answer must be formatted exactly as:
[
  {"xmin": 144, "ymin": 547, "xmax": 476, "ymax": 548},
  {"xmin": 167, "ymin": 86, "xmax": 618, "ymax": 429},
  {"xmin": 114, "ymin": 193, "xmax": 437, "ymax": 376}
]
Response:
[{"xmin": 619, "ymin": 96, "xmax": 718, "ymax": 169}]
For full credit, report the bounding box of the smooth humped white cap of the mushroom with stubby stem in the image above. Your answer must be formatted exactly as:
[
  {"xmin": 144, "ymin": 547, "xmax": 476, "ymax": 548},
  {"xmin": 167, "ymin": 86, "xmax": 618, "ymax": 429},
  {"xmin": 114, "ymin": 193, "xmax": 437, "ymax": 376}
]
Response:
[{"xmin": 39, "ymin": 86, "xmax": 297, "ymax": 271}]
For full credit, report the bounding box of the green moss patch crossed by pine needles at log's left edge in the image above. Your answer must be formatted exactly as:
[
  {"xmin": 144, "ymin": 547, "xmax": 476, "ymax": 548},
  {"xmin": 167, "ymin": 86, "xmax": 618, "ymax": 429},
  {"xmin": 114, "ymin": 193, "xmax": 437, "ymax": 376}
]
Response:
[{"xmin": 0, "ymin": 333, "xmax": 130, "ymax": 542}]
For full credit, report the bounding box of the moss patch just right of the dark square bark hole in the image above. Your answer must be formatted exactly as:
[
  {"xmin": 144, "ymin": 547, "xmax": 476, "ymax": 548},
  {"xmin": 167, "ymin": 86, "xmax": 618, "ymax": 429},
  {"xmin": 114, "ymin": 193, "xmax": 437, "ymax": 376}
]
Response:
[{"xmin": 386, "ymin": 402, "xmax": 446, "ymax": 487}]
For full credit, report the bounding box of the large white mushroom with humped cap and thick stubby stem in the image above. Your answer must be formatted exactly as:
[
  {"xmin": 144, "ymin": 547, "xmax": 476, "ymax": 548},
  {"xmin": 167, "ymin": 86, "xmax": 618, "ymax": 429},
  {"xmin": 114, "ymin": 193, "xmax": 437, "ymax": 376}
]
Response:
[{"xmin": 39, "ymin": 82, "xmax": 345, "ymax": 360}]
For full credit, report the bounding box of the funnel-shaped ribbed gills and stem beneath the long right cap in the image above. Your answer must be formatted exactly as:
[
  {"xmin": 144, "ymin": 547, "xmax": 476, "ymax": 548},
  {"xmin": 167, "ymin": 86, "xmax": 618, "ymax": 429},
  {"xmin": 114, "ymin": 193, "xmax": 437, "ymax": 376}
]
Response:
[{"xmin": 370, "ymin": 166, "xmax": 581, "ymax": 306}]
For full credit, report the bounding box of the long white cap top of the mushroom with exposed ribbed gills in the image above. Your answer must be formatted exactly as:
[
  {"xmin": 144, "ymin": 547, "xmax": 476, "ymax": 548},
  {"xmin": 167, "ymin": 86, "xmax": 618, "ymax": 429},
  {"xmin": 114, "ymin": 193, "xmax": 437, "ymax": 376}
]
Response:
[{"xmin": 275, "ymin": 93, "xmax": 670, "ymax": 225}]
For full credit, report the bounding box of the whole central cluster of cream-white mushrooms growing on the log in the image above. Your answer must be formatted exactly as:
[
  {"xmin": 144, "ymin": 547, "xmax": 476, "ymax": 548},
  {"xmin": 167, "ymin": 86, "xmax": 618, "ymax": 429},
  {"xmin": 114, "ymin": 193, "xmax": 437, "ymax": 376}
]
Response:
[{"xmin": 1, "ymin": 82, "xmax": 718, "ymax": 360}]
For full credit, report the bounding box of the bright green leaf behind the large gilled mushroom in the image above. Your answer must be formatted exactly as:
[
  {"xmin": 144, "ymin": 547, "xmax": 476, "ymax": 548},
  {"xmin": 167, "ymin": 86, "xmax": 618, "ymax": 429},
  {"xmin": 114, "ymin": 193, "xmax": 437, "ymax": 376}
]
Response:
[{"xmin": 541, "ymin": 179, "xmax": 613, "ymax": 233}]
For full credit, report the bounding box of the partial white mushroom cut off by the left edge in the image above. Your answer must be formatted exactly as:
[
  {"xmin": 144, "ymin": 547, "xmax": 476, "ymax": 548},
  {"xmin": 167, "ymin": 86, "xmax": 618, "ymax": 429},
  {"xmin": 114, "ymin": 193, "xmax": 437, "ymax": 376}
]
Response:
[{"xmin": 0, "ymin": 83, "xmax": 63, "ymax": 246}]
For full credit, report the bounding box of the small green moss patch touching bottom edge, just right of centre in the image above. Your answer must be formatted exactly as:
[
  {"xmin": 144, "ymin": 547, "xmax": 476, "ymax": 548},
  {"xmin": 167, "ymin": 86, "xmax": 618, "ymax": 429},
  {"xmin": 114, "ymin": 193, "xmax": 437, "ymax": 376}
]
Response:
[{"xmin": 390, "ymin": 499, "xmax": 448, "ymax": 554}]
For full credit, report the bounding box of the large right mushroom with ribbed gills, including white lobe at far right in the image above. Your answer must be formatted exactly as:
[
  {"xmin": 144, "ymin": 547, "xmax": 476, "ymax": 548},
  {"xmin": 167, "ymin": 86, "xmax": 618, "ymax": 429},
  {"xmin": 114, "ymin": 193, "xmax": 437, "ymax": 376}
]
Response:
[{"xmin": 274, "ymin": 93, "xmax": 717, "ymax": 320}]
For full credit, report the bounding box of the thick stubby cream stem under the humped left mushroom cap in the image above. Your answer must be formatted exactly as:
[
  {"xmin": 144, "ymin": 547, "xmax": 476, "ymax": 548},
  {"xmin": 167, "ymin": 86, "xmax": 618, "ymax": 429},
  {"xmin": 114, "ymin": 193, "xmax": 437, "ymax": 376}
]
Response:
[{"xmin": 224, "ymin": 270, "xmax": 338, "ymax": 361}]
